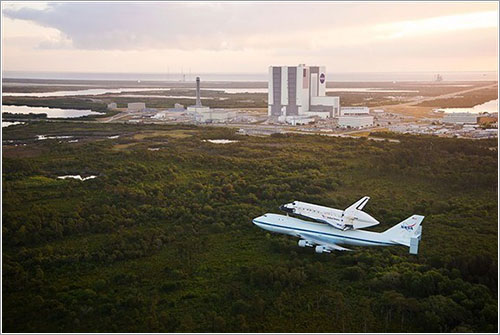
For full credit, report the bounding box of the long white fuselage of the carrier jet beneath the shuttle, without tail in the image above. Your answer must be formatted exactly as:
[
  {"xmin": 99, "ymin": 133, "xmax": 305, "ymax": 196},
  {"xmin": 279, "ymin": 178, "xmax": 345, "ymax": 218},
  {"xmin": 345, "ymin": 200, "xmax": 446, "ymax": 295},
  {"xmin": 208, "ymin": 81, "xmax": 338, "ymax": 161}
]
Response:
[{"xmin": 253, "ymin": 213, "xmax": 398, "ymax": 246}]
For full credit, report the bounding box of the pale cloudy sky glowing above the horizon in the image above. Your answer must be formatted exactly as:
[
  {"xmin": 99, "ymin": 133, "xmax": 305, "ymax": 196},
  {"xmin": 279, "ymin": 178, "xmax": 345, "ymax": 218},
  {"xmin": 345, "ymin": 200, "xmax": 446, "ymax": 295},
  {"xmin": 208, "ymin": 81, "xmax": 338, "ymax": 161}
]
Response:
[{"xmin": 2, "ymin": 1, "xmax": 498, "ymax": 73}]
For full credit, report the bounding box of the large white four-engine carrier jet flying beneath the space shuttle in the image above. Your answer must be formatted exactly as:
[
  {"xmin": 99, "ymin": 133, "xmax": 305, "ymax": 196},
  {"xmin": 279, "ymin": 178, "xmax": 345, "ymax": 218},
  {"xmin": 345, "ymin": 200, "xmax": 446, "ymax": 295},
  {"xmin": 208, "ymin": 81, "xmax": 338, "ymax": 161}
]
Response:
[{"xmin": 253, "ymin": 197, "xmax": 424, "ymax": 255}]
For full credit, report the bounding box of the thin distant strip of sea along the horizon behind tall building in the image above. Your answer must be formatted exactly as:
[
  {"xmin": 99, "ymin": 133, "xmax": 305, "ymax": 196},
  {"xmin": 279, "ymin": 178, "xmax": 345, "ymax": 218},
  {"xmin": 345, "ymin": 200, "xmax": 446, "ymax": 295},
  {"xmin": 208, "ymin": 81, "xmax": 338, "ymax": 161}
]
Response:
[{"xmin": 2, "ymin": 71, "xmax": 498, "ymax": 82}]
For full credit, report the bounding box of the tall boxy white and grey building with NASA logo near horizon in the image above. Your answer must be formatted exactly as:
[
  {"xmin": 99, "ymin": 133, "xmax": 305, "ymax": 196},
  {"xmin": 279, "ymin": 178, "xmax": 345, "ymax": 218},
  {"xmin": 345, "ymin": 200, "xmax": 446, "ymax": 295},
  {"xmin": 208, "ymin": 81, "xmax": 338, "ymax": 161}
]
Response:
[{"xmin": 268, "ymin": 64, "xmax": 340, "ymax": 121}]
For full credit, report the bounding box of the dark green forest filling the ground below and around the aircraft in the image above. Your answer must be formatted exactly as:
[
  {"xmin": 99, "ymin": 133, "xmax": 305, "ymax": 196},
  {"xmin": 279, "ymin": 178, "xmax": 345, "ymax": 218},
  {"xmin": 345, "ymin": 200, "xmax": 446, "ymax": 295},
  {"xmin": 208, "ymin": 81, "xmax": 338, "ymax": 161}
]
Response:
[{"xmin": 2, "ymin": 121, "xmax": 498, "ymax": 333}]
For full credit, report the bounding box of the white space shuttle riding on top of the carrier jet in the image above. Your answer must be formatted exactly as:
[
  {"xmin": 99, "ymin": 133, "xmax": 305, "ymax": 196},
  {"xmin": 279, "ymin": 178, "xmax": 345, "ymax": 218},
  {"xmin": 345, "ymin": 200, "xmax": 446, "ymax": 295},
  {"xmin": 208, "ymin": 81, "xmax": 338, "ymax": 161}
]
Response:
[{"xmin": 280, "ymin": 196, "xmax": 380, "ymax": 231}]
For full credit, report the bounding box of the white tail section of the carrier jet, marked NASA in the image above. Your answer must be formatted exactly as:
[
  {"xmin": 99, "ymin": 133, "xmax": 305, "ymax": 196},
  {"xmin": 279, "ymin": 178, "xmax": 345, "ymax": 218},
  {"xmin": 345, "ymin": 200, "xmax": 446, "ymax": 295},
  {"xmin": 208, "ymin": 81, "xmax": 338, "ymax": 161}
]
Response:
[{"xmin": 383, "ymin": 215, "xmax": 424, "ymax": 255}]
